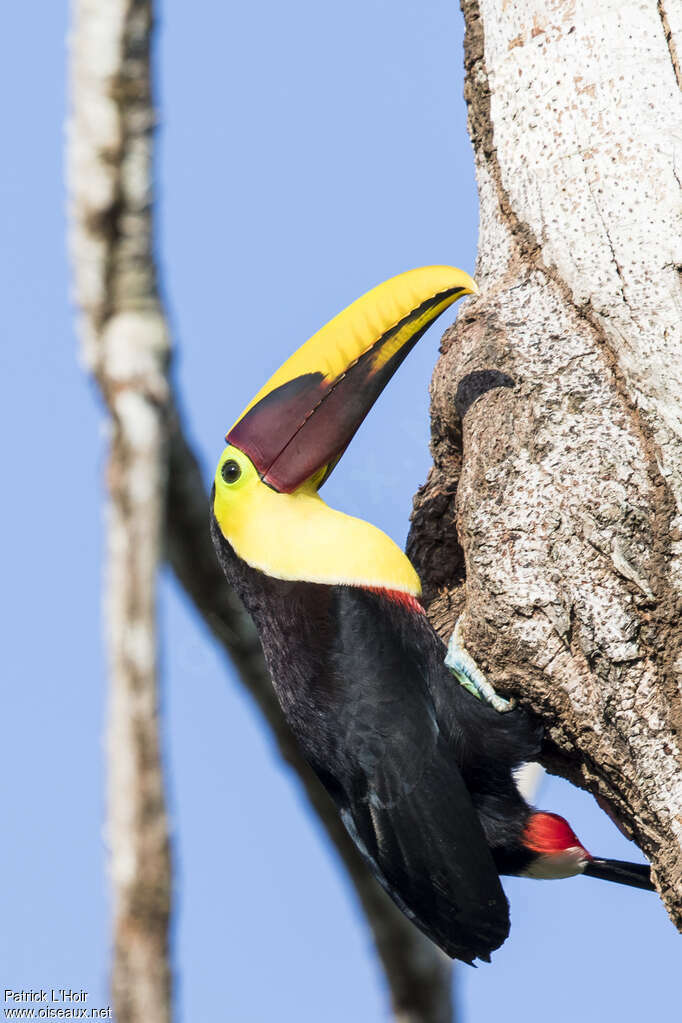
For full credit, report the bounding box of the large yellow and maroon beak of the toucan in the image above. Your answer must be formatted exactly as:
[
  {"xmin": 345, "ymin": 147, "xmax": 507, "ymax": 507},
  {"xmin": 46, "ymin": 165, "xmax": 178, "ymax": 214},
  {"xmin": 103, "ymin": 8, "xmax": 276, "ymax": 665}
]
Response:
[{"xmin": 226, "ymin": 266, "xmax": 479, "ymax": 493}]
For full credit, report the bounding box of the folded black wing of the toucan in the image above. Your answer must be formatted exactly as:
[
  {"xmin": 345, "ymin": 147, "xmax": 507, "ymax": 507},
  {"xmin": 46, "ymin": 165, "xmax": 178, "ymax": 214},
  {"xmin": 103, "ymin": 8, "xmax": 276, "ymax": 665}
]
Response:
[{"xmin": 321, "ymin": 587, "xmax": 509, "ymax": 962}]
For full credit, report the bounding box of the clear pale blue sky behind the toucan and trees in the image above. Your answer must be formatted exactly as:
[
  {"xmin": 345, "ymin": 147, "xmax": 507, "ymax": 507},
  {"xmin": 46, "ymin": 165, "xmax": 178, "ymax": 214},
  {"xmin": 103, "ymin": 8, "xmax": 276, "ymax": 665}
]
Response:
[{"xmin": 0, "ymin": 0, "xmax": 682, "ymax": 1023}]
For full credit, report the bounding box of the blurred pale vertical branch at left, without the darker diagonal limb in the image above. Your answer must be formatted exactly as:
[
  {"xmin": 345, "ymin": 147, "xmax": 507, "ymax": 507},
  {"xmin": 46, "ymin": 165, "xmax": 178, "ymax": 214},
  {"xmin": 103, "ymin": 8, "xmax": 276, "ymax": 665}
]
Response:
[{"xmin": 69, "ymin": 0, "xmax": 171, "ymax": 1023}]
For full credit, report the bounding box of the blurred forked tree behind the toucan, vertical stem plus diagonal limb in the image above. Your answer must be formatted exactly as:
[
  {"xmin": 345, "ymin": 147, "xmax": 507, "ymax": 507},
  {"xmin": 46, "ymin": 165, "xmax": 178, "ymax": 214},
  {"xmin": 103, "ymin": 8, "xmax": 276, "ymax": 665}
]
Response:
[{"xmin": 69, "ymin": 0, "xmax": 452, "ymax": 1023}]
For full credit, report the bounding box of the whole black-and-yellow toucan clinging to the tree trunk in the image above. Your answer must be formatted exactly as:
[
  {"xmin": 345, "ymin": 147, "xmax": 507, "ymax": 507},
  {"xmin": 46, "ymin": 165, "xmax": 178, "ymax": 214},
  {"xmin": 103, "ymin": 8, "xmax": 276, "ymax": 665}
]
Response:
[{"xmin": 211, "ymin": 266, "xmax": 652, "ymax": 964}]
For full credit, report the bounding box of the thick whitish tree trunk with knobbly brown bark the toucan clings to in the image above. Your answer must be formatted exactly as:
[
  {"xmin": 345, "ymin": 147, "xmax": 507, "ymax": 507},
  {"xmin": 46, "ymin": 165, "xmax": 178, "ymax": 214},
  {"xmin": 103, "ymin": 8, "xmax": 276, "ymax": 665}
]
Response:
[{"xmin": 409, "ymin": 0, "xmax": 682, "ymax": 927}]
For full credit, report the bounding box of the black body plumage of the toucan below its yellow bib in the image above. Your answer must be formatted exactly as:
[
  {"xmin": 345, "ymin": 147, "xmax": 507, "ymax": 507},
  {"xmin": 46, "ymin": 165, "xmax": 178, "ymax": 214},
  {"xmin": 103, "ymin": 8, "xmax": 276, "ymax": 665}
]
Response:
[{"xmin": 212, "ymin": 515, "xmax": 541, "ymax": 962}]
